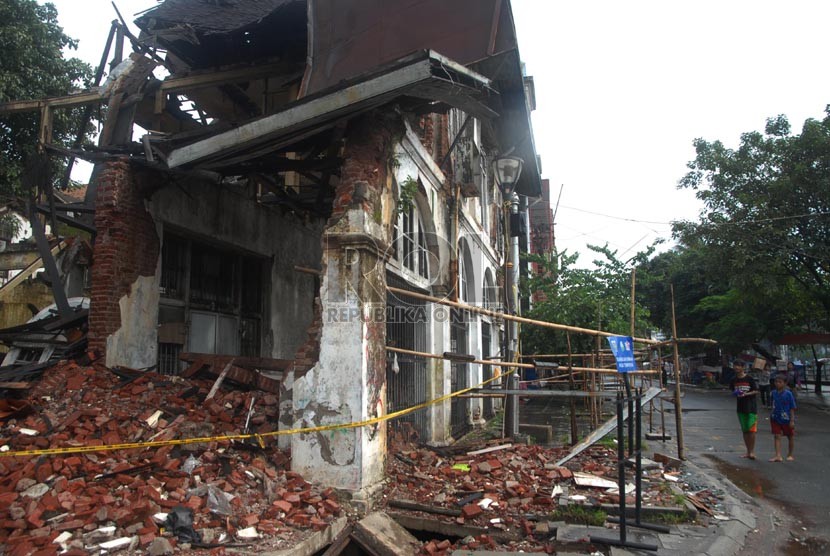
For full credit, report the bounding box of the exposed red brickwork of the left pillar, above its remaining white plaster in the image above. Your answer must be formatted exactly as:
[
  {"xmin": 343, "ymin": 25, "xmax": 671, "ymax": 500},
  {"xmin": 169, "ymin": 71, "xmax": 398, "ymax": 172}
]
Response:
[{"xmin": 89, "ymin": 159, "xmax": 159, "ymax": 355}]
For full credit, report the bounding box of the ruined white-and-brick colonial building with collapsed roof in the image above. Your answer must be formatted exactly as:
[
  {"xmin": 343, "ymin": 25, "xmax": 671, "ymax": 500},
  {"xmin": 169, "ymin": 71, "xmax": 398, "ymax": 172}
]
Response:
[{"xmin": 0, "ymin": 0, "xmax": 541, "ymax": 500}]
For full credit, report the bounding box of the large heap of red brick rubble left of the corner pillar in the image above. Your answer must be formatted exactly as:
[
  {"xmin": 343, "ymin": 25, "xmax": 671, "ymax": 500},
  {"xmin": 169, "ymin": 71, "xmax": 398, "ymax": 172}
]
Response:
[{"xmin": 0, "ymin": 362, "xmax": 344, "ymax": 554}]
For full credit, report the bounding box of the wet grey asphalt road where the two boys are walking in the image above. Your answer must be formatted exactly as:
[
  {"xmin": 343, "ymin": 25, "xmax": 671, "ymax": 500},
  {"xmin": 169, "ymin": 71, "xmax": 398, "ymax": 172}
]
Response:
[{"xmin": 666, "ymin": 389, "xmax": 830, "ymax": 555}]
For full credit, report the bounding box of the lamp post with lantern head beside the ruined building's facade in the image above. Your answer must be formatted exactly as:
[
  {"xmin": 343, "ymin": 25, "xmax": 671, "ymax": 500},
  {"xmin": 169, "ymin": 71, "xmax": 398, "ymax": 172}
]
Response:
[{"xmin": 493, "ymin": 156, "xmax": 524, "ymax": 437}]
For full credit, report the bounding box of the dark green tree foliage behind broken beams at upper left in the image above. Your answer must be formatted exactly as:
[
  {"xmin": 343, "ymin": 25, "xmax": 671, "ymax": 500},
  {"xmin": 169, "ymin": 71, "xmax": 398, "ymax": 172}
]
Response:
[{"xmin": 0, "ymin": 0, "xmax": 92, "ymax": 198}]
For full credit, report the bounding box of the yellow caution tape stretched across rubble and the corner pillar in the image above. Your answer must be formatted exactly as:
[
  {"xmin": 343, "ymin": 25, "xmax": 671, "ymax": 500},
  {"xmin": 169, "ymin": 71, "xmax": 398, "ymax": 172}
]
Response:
[{"xmin": 0, "ymin": 369, "xmax": 516, "ymax": 458}]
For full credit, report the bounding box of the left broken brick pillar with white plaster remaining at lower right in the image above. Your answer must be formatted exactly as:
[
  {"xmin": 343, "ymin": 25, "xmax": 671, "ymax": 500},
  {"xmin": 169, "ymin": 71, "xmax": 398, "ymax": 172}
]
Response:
[{"xmin": 88, "ymin": 159, "xmax": 159, "ymax": 368}]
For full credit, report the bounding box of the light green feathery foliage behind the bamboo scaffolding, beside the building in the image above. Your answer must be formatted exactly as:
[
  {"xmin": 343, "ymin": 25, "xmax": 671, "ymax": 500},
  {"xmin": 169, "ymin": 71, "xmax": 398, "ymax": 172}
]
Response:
[{"xmin": 522, "ymin": 245, "xmax": 653, "ymax": 354}]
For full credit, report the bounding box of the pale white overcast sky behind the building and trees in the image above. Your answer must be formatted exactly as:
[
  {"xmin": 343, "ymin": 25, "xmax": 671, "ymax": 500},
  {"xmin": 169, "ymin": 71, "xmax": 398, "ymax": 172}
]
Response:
[{"xmin": 44, "ymin": 0, "xmax": 830, "ymax": 264}]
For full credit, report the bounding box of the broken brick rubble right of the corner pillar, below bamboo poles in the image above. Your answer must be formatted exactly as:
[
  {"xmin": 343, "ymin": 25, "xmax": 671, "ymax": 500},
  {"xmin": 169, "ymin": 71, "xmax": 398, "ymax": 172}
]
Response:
[{"xmin": 384, "ymin": 426, "xmax": 720, "ymax": 555}]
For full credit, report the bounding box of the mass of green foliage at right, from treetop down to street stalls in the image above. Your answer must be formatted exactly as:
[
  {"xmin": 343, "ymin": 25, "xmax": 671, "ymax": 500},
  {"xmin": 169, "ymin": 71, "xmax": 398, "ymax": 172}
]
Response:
[{"xmin": 652, "ymin": 111, "xmax": 830, "ymax": 353}]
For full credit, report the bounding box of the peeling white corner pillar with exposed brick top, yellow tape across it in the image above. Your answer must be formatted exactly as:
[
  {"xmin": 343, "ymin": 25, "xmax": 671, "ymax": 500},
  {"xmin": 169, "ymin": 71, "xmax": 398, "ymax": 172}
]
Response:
[{"xmin": 291, "ymin": 115, "xmax": 396, "ymax": 507}]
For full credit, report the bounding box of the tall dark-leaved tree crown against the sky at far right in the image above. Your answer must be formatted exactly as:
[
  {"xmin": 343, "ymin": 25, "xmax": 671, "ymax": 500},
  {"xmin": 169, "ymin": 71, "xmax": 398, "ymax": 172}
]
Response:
[{"xmin": 674, "ymin": 107, "xmax": 830, "ymax": 334}]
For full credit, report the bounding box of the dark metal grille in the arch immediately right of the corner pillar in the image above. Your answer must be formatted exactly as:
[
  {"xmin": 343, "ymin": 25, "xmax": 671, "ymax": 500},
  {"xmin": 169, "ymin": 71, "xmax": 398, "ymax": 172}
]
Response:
[{"xmin": 386, "ymin": 284, "xmax": 429, "ymax": 439}]
